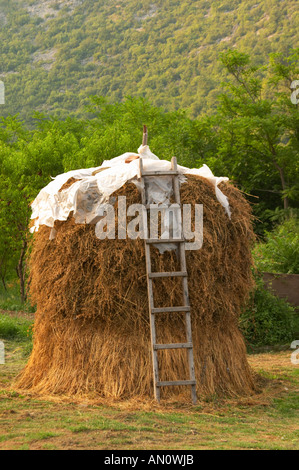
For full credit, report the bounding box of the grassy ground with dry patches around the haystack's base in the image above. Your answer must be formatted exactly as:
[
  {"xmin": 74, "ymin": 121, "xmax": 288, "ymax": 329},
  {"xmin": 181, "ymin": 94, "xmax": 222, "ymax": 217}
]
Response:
[{"xmin": 0, "ymin": 314, "xmax": 299, "ymax": 450}]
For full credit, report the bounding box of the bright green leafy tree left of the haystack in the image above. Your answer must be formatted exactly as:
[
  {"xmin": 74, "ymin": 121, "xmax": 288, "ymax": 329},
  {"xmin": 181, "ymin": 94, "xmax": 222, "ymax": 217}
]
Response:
[{"xmin": 0, "ymin": 116, "xmax": 83, "ymax": 302}]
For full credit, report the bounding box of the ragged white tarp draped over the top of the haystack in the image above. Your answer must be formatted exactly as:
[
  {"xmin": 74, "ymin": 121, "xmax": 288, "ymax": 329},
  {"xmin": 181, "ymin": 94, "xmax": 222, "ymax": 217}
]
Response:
[{"xmin": 30, "ymin": 145, "xmax": 230, "ymax": 238}]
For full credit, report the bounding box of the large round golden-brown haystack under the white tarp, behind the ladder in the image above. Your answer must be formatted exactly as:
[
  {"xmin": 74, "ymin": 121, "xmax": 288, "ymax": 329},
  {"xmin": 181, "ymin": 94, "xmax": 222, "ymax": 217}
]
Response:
[{"xmin": 17, "ymin": 176, "xmax": 255, "ymax": 397}]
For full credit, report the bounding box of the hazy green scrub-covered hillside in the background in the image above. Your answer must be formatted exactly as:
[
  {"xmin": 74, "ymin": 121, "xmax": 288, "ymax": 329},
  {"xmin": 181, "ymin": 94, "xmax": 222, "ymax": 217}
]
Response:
[{"xmin": 0, "ymin": 0, "xmax": 299, "ymax": 120}]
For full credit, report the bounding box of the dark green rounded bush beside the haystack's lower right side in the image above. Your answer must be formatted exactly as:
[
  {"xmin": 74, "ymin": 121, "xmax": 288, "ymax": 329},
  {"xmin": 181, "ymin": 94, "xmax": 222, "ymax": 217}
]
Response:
[{"xmin": 240, "ymin": 279, "xmax": 296, "ymax": 347}]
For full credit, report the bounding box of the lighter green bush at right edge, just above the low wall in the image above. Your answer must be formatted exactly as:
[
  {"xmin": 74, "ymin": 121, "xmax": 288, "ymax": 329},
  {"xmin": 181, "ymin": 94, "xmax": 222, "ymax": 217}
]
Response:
[{"xmin": 253, "ymin": 218, "xmax": 299, "ymax": 274}]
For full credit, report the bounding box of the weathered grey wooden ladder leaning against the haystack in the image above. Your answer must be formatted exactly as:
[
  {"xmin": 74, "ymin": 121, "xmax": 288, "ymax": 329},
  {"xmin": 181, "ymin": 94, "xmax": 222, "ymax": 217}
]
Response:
[{"xmin": 140, "ymin": 157, "xmax": 197, "ymax": 404}]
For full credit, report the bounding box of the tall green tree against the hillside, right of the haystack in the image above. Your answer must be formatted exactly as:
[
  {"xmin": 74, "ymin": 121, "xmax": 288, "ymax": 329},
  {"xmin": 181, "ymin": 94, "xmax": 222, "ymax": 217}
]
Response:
[{"xmin": 214, "ymin": 50, "xmax": 299, "ymax": 218}]
